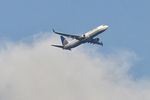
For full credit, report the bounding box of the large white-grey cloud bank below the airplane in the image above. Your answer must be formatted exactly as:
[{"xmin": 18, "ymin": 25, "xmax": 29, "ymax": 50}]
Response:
[{"xmin": 0, "ymin": 32, "xmax": 150, "ymax": 100}]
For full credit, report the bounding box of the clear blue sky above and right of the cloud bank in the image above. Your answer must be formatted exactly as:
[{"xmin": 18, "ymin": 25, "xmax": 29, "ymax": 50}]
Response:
[{"xmin": 0, "ymin": 0, "xmax": 150, "ymax": 77}]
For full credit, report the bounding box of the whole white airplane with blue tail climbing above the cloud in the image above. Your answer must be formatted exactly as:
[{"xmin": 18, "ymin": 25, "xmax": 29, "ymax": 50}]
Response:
[{"xmin": 51, "ymin": 25, "xmax": 108, "ymax": 50}]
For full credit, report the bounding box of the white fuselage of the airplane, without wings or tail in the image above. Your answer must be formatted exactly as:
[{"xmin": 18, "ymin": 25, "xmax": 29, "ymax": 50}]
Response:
[{"xmin": 64, "ymin": 25, "xmax": 108, "ymax": 50}]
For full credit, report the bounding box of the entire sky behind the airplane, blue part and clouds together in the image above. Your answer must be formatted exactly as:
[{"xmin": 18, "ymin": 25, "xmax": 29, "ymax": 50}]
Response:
[{"xmin": 0, "ymin": 0, "xmax": 150, "ymax": 100}]
